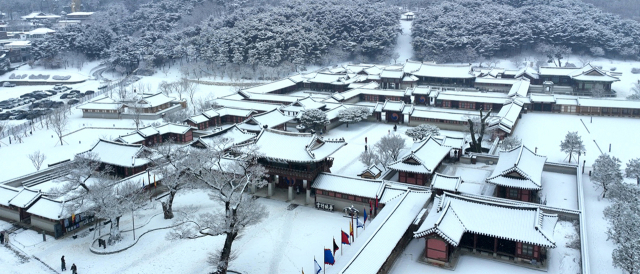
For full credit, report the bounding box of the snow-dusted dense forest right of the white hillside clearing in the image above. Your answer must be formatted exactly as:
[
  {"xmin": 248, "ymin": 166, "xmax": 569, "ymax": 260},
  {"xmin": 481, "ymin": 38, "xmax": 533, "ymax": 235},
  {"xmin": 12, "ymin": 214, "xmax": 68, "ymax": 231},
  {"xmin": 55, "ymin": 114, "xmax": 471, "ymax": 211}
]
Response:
[{"xmin": 412, "ymin": 0, "xmax": 640, "ymax": 62}]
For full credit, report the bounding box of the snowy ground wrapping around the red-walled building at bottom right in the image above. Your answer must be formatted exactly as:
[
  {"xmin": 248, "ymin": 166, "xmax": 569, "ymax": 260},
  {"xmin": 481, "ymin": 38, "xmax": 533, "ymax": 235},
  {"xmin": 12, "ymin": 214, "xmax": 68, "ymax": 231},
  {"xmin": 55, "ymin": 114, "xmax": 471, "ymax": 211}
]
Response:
[{"xmin": 389, "ymin": 221, "xmax": 584, "ymax": 274}]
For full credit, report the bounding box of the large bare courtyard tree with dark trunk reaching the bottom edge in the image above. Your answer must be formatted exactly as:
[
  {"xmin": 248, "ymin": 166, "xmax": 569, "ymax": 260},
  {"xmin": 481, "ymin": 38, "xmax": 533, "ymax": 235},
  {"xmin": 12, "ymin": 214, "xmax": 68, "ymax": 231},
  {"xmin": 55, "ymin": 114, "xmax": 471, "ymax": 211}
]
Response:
[{"xmin": 169, "ymin": 143, "xmax": 267, "ymax": 274}]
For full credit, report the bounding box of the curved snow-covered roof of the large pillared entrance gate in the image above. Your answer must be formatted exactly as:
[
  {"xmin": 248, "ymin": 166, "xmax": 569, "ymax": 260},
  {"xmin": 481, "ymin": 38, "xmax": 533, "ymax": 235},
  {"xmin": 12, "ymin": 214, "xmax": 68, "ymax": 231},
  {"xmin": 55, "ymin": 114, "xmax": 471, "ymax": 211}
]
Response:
[{"xmin": 255, "ymin": 129, "xmax": 347, "ymax": 162}]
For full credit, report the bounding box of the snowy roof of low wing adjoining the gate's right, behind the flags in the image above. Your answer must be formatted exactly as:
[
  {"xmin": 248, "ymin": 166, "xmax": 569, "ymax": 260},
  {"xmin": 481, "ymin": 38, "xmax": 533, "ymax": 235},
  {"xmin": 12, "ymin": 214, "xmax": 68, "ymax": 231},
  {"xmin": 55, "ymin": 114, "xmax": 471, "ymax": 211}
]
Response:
[{"xmin": 311, "ymin": 172, "xmax": 384, "ymax": 199}]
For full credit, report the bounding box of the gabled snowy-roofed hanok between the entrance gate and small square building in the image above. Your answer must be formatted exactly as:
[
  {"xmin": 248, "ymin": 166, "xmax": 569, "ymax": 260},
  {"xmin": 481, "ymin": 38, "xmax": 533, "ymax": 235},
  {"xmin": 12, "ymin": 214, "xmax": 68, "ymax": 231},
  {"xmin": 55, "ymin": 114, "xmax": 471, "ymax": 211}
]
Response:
[{"xmin": 388, "ymin": 136, "xmax": 452, "ymax": 186}]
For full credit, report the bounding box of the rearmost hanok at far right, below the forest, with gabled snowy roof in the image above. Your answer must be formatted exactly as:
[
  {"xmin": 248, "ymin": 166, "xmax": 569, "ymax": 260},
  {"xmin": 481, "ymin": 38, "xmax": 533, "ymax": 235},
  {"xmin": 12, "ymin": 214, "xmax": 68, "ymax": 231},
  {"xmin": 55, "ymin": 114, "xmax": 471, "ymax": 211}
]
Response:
[{"xmin": 539, "ymin": 64, "xmax": 620, "ymax": 97}]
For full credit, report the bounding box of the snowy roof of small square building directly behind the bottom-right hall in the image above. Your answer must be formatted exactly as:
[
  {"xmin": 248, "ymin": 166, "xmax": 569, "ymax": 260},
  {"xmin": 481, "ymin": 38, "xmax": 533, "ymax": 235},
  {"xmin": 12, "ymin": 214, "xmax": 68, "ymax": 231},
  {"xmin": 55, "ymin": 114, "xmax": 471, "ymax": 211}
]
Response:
[{"xmin": 487, "ymin": 145, "xmax": 547, "ymax": 190}]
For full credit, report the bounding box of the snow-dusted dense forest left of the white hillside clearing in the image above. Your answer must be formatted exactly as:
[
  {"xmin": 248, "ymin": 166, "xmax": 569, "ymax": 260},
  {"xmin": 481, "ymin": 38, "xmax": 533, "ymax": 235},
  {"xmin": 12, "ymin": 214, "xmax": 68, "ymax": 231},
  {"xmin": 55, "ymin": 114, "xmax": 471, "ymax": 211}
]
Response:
[{"xmin": 27, "ymin": 0, "xmax": 400, "ymax": 73}]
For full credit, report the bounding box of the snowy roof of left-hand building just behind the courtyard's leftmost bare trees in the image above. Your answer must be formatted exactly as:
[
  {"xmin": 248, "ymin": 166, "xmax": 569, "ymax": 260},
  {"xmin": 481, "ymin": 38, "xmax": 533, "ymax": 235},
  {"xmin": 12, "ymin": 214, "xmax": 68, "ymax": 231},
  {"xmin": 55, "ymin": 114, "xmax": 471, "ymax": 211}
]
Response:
[{"xmin": 76, "ymin": 139, "xmax": 149, "ymax": 167}]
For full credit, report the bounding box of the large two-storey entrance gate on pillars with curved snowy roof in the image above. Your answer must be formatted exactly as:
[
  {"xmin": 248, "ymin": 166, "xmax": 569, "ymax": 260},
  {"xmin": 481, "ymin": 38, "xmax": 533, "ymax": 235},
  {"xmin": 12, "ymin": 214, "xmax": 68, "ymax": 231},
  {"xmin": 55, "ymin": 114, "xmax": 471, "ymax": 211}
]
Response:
[{"xmin": 250, "ymin": 129, "xmax": 347, "ymax": 202}]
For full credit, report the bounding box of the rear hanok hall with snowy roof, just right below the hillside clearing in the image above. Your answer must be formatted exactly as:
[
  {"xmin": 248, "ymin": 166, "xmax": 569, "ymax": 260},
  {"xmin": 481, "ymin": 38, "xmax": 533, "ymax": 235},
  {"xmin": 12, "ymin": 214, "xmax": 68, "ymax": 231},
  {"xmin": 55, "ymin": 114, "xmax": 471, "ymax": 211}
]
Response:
[{"xmin": 412, "ymin": 63, "xmax": 475, "ymax": 87}]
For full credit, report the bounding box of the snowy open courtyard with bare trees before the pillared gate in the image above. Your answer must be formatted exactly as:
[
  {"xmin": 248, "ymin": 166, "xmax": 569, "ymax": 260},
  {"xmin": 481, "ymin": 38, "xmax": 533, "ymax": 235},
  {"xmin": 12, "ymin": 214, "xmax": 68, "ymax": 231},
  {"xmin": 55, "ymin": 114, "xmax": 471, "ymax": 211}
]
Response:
[{"xmin": 0, "ymin": 192, "xmax": 360, "ymax": 273}]
